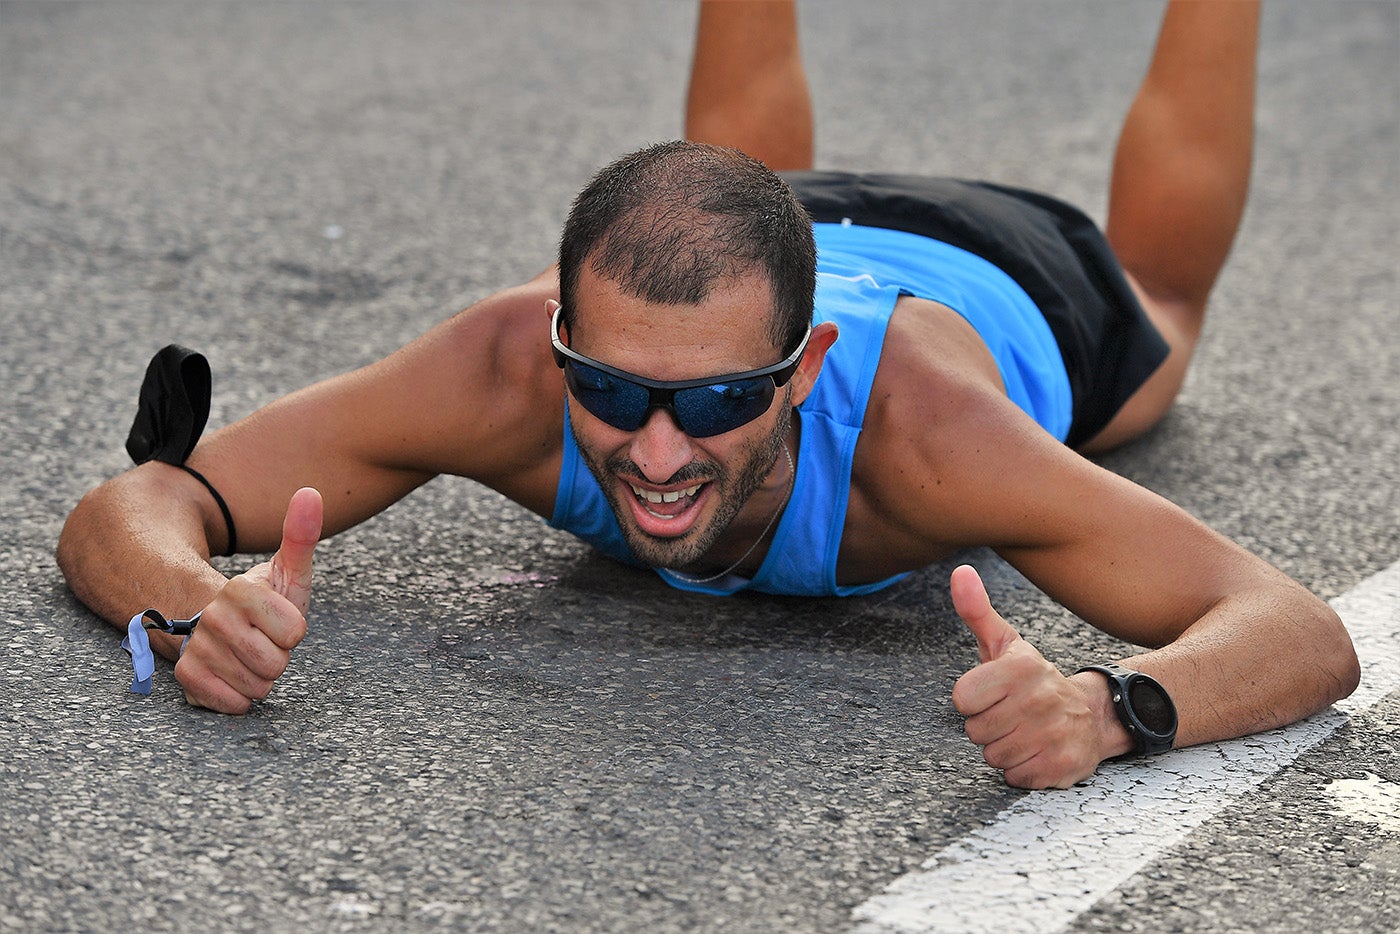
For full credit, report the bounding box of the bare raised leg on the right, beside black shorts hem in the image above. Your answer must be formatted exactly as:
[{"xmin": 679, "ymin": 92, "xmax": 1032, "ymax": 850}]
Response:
[{"xmin": 1085, "ymin": 0, "xmax": 1259, "ymax": 452}]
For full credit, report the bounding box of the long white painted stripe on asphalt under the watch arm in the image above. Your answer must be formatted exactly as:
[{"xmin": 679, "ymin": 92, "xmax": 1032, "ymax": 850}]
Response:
[{"xmin": 853, "ymin": 563, "xmax": 1400, "ymax": 934}]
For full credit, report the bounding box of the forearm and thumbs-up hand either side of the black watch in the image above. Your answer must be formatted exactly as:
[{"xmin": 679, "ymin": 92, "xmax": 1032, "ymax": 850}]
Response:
[{"xmin": 952, "ymin": 569, "xmax": 1359, "ymax": 788}]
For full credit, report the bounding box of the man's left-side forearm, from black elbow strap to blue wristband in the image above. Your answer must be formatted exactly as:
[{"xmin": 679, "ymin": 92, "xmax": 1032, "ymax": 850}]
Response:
[{"xmin": 57, "ymin": 463, "xmax": 225, "ymax": 658}]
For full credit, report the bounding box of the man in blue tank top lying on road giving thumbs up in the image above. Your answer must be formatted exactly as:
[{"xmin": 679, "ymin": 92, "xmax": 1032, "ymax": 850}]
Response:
[{"xmin": 59, "ymin": 0, "xmax": 1358, "ymax": 787}]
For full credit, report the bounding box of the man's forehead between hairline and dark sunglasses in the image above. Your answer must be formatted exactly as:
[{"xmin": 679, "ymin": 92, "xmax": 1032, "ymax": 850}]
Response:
[{"xmin": 568, "ymin": 264, "xmax": 778, "ymax": 379}]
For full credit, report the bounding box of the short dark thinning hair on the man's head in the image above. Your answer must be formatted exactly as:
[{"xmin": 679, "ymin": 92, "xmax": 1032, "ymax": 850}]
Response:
[{"xmin": 559, "ymin": 140, "xmax": 816, "ymax": 351}]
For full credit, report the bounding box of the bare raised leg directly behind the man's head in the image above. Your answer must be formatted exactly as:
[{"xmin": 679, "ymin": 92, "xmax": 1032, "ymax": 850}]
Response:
[{"xmin": 686, "ymin": 0, "xmax": 812, "ymax": 171}]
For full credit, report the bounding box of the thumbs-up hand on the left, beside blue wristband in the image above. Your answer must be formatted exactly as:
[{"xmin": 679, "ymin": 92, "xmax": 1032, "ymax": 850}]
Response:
[{"xmin": 175, "ymin": 487, "xmax": 323, "ymax": 714}]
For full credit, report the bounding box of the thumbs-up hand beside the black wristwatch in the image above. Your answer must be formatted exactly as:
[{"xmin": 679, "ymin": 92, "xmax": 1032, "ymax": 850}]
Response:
[{"xmin": 951, "ymin": 564, "xmax": 1103, "ymax": 788}]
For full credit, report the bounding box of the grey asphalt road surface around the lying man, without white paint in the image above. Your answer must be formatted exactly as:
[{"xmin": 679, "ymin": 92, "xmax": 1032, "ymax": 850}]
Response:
[{"xmin": 0, "ymin": 0, "xmax": 1400, "ymax": 931}]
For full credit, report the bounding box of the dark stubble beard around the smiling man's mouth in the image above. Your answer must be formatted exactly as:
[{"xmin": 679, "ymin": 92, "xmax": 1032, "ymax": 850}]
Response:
[{"xmin": 574, "ymin": 392, "xmax": 792, "ymax": 570}]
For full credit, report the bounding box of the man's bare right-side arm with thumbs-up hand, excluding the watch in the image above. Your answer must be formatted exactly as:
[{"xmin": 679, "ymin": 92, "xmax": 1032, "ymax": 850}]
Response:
[{"xmin": 862, "ymin": 372, "xmax": 1359, "ymax": 787}]
